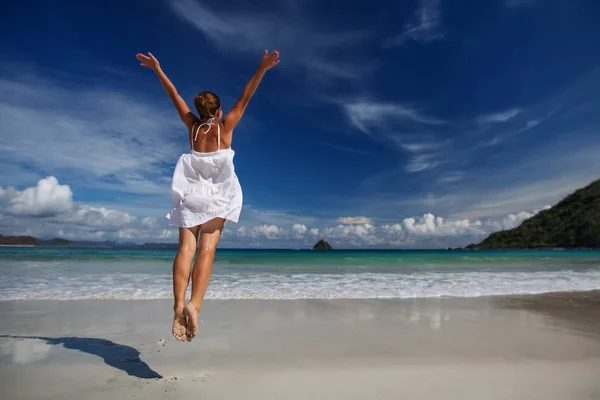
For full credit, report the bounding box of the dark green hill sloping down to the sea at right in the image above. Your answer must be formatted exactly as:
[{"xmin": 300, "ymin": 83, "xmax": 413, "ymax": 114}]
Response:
[{"xmin": 467, "ymin": 179, "xmax": 600, "ymax": 249}]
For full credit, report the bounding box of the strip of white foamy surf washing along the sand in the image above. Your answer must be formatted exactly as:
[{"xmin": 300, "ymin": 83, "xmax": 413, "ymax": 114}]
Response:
[{"xmin": 0, "ymin": 270, "xmax": 600, "ymax": 300}]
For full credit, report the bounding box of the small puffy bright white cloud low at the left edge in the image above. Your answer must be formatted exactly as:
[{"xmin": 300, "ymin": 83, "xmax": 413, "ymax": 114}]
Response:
[{"xmin": 0, "ymin": 176, "xmax": 73, "ymax": 217}]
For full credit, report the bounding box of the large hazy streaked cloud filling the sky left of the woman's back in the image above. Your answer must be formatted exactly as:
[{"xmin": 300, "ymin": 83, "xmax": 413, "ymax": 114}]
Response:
[{"xmin": 0, "ymin": 77, "xmax": 185, "ymax": 194}]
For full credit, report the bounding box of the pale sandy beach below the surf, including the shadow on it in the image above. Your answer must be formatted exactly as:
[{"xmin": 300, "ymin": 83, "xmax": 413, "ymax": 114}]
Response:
[{"xmin": 0, "ymin": 292, "xmax": 600, "ymax": 400}]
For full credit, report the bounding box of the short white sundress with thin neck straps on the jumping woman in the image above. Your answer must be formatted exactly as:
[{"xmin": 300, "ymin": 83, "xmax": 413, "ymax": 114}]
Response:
[{"xmin": 167, "ymin": 119, "xmax": 243, "ymax": 228}]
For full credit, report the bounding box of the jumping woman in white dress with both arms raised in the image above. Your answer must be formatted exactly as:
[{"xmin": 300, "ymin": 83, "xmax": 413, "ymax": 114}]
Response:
[{"xmin": 137, "ymin": 50, "xmax": 279, "ymax": 342}]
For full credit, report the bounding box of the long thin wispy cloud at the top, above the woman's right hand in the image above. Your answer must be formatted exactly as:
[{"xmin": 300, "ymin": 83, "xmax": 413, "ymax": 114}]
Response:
[{"xmin": 170, "ymin": 0, "xmax": 373, "ymax": 79}]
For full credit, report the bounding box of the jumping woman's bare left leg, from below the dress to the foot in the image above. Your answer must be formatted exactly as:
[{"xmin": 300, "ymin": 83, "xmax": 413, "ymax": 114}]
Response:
[{"xmin": 173, "ymin": 226, "xmax": 200, "ymax": 342}]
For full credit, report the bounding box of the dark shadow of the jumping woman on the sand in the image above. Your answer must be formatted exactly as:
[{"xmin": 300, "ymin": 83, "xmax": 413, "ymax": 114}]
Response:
[{"xmin": 0, "ymin": 335, "xmax": 162, "ymax": 379}]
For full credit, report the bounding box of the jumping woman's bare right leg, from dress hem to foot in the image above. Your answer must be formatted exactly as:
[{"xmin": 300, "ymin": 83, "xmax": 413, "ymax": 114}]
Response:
[{"xmin": 186, "ymin": 218, "xmax": 225, "ymax": 340}]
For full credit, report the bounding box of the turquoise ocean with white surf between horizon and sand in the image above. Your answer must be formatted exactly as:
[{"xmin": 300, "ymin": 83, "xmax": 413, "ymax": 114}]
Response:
[{"xmin": 0, "ymin": 247, "xmax": 600, "ymax": 300}]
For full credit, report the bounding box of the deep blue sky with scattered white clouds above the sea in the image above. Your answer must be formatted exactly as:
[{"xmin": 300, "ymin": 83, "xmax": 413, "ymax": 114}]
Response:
[{"xmin": 0, "ymin": 0, "xmax": 600, "ymax": 248}]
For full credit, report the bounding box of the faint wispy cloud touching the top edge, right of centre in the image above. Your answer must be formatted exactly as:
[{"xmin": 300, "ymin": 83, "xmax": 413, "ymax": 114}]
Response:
[{"xmin": 385, "ymin": 0, "xmax": 444, "ymax": 47}]
